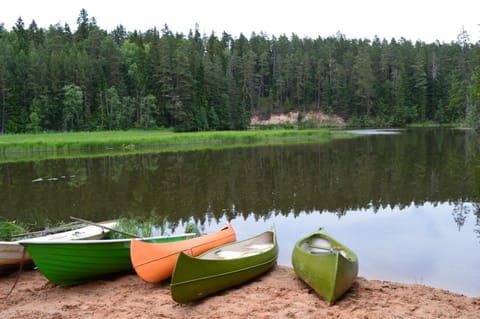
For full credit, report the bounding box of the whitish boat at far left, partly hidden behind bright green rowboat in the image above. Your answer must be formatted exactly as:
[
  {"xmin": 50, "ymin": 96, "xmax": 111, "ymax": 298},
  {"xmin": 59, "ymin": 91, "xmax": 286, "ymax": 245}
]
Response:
[{"xmin": 0, "ymin": 221, "xmax": 117, "ymax": 269}]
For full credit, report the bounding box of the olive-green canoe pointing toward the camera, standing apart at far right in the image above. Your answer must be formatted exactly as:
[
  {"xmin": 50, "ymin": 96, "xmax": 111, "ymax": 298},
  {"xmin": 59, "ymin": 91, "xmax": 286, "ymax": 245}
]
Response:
[{"xmin": 292, "ymin": 229, "xmax": 358, "ymax": 304}]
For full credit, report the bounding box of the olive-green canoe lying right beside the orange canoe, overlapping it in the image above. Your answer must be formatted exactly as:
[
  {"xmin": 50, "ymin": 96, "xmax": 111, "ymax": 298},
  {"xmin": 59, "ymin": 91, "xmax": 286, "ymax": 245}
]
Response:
[{"xmin": 170, "ymin": 229, "xmax": 278, "ymax": 303}]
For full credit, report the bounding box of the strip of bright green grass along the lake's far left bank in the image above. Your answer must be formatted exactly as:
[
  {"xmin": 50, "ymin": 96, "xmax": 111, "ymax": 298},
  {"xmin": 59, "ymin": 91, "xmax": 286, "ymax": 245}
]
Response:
[{"xmin": 0, "ymin": 130, "xmax": 348, "ymax": 163}]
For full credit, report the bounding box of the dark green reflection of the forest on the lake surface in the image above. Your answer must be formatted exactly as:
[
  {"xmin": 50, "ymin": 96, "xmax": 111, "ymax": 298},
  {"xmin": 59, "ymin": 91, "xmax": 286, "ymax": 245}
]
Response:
[{"xmin": 0, "ymin": 129, "xmax": 480, "ymax": 232}]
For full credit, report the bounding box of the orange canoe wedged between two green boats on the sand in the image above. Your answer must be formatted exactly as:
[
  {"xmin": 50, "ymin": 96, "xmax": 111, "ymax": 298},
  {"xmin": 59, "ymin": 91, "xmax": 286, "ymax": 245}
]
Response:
[{"xmin": 130, "ymin": 223, "xmax": 236, "ymax": 283}]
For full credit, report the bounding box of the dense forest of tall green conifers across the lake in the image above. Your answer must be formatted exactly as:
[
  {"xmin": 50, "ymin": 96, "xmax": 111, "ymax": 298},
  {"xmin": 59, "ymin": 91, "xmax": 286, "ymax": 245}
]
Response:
[{"xmin": 0, "ymin": 9, "xmax": 480, "ymax": 133}]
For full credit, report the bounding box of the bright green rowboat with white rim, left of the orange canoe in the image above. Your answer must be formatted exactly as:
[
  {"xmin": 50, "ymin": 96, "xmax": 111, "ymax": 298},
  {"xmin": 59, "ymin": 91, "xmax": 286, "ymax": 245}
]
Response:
[{"xmin": 20, "ymin": 234, "xmax": 195, "ymax": 285}]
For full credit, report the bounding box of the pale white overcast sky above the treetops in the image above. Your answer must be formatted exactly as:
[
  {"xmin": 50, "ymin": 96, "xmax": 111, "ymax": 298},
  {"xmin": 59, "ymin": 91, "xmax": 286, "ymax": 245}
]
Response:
[{"xmin": 0, "ymin": 0, "xmax": 480, "ymax": 43}]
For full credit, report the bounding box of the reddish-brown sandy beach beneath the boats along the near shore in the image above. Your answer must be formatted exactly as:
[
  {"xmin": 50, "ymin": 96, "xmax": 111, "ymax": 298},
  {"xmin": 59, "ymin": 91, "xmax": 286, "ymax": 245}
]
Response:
[{"xmin": 0, "ymin": 266, "xmax": 480, "ymax": 319}]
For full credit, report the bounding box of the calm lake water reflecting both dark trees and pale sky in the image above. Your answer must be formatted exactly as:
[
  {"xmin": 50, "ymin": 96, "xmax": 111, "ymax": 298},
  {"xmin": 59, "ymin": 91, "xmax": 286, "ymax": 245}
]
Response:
[{"xmin": 0, "ymin": 129, "xmax": 480, "ymax": 296}]
